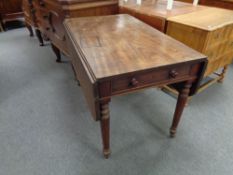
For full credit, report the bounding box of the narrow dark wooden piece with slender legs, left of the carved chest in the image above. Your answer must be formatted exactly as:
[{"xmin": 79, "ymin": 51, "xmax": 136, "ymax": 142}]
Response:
[{"xmin": 22, "ymin": 0, "xmax": 44, "ymax": 46}]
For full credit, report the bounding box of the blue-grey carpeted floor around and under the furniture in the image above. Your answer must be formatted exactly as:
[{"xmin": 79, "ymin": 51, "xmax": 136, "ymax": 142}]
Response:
[{"xmin": 0, "ymin": 28, "xmax": 233, "ymax": 175}]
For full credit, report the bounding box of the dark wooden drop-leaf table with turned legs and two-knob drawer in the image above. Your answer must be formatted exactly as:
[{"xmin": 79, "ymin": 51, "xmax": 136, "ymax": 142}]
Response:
[{"xmin": 64, "ymin": 15, "xmax": 207, "ymax": 158}]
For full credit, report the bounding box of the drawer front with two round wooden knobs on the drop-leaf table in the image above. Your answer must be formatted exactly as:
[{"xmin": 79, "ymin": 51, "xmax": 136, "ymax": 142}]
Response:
[{"xmin": 112, "ymin": 65, "xmax": 191, "ymax": 94}]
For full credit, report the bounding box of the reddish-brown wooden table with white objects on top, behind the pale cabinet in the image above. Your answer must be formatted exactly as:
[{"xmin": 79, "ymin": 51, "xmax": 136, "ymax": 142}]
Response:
[{"xmin": 119, "ymin": 0, "xmax": 205, "ymax": 33}]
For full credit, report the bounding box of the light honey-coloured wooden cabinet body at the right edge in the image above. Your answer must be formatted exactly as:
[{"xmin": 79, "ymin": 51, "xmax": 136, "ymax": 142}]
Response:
[{"xmin": 167, "ymin": 8, "xmax": 233, "ymax": 76}]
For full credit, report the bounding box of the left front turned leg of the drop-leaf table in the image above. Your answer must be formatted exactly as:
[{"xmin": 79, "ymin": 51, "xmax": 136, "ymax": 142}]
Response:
[{"xmin": 100, "ymin": 101, "xmax": 111, "ymax": 159}]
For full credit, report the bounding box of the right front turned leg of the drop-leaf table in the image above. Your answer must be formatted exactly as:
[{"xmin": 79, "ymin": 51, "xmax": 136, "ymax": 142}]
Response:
[{"xmin": 170, "ymin": 81, "xmax": 192, "ymax": 137}]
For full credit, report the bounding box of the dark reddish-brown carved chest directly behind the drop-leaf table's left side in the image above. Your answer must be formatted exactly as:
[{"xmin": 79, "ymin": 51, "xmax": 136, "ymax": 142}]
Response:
[{"xmin": 32, "ymin": 0, "xmax": 118, "ymax": 62}]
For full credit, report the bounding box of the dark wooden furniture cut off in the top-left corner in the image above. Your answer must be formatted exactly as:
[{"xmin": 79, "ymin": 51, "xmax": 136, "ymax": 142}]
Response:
[{"xmin": 0, "ymin": 0, "xmax": 23, "ymax": 30}]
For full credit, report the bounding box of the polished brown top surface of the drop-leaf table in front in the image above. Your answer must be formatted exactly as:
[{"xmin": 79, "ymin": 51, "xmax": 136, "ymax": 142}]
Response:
[{"xmin": 65, "ymin": 15, "xmax": 205, "ymax": 79}]
